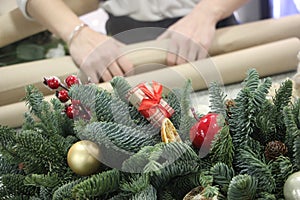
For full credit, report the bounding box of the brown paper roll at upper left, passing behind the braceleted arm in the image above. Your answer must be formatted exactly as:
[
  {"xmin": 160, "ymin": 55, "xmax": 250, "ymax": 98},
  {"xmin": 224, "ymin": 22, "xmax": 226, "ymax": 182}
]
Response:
[{"xmin": 0, "ymin": 0, "xmax": 99, "ymax": 48}]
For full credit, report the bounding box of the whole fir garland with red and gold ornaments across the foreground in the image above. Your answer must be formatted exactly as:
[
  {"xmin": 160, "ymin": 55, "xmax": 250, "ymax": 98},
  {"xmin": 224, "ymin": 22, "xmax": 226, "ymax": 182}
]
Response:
[{"xmin": 0, "ymin": 69, "xmax": 300, "ymax": 200}]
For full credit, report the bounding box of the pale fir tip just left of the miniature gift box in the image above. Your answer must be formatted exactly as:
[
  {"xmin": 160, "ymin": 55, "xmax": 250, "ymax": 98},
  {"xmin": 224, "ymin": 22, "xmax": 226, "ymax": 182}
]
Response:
[{"xmin": 110, "ymin": 76, "xmax": 131, "ymax": 103}]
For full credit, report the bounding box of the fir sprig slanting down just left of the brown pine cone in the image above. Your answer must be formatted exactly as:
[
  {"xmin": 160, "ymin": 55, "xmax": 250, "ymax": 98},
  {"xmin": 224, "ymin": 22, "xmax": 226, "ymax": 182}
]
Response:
[{"xmin": 238, "ymin": 147, "xmax": 275, "ymax": 192}]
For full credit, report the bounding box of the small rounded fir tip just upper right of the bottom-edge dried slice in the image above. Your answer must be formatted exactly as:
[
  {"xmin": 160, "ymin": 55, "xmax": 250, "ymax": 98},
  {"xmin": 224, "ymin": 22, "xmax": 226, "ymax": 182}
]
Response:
[{"xmin": 210, "ymin": 162, "xmax": 235, "ymax": 194}]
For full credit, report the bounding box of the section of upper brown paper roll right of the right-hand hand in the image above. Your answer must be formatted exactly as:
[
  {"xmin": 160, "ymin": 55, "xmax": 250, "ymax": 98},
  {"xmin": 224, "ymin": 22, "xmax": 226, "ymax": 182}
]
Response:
[{"xmin": 209, "ymin": 14, "xmax": 300, "ymax": 56}]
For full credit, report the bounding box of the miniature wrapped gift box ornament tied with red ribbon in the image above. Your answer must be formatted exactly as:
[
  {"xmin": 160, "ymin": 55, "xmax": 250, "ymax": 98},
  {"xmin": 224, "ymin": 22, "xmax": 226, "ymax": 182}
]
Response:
[{"xmin": 127, "ymin": 81, "xmax": 174, "ymax": 127}]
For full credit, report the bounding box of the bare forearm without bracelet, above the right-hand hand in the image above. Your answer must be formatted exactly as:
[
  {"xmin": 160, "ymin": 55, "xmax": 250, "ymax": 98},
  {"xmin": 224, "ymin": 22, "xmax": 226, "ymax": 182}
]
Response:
[{"xmin": 193, "ymin": 0, "xmax": 249, "ymax": 23}]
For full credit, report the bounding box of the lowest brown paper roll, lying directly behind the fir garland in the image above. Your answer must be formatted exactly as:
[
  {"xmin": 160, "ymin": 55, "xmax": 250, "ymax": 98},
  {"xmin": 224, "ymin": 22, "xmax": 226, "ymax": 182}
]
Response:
[{"xmin": 0, "ymin": 38, "xmax": 300, "ymax": 127}]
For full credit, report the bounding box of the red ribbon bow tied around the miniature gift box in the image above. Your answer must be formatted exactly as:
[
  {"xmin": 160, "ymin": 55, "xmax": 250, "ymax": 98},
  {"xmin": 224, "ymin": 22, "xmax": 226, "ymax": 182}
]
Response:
[{"xmin": 138, "ymin": 81, "xmax": 171, "ymax": 118}]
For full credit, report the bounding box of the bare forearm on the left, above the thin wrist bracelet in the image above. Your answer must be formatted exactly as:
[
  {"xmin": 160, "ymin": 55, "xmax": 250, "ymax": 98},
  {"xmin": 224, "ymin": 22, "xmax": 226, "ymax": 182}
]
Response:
[{"xmin": 27, "ymin": 0, "xmax": 98, "ymax": 41}]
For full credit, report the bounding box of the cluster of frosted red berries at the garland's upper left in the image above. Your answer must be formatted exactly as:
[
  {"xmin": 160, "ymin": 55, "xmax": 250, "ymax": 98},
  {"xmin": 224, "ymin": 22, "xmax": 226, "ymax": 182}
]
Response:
[{"xmin": 44, "ymin": 75, "xmax": 91, "ymax": 120}]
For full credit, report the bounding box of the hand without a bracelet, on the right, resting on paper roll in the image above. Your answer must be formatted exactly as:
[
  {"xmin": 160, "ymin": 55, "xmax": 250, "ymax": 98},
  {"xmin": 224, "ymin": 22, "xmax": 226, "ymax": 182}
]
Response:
[{"xmin": 158, "ymin": 12, "xmax": 216, "ymax": 66}]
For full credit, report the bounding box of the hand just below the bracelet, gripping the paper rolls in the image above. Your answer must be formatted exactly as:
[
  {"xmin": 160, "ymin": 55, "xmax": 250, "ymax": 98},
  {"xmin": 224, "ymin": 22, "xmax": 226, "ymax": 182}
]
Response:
[{"xmin": 70, "ymin": 27, "xmax": 133, "ymax": 83}]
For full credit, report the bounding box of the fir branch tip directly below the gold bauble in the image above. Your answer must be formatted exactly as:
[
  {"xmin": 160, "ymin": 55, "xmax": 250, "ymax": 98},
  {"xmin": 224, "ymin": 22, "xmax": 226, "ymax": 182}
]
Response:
[{"xmin": 72, "ymin": 169, "xmax": 120, "ymax": 199}]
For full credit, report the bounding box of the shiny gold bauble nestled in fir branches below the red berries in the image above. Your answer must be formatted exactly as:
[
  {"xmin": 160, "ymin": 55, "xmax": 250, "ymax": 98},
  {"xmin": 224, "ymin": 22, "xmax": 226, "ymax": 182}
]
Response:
[{"xmin": 67, "ymin": 140, "xmax": 101, "ymax": 176}]
